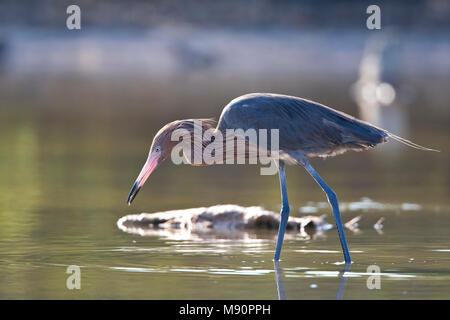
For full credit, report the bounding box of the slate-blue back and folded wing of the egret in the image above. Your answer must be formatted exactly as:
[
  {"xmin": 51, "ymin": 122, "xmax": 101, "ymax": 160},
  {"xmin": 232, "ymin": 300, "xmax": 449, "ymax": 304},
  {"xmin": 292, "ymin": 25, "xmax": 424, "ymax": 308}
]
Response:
[{"xmin": 218, "ymin": 93, "xmax": 388, "ymax": 156}]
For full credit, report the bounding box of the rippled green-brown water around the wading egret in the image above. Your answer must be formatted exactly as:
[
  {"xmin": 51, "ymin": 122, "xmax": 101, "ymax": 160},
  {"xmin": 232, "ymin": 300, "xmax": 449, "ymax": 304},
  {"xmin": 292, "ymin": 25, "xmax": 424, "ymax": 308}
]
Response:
[{"xmin": 0, "ymin": 78, "xmax": 450, "ymax": 299}]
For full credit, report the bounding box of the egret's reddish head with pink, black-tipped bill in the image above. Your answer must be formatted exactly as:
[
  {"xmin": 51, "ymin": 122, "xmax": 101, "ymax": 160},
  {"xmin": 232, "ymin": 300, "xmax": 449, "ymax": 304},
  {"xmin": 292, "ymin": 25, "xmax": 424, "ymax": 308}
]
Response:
[{"xmin": 127, "ymin": 119, "xmax": 213, "ymax": 205}]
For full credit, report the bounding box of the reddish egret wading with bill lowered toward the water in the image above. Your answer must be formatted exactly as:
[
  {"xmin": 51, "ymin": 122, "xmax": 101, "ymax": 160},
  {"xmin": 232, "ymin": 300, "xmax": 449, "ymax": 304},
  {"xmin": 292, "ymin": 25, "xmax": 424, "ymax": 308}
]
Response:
[{"xmin": 127, "ymin": 93, "xmax": 436, "ymax": 263}]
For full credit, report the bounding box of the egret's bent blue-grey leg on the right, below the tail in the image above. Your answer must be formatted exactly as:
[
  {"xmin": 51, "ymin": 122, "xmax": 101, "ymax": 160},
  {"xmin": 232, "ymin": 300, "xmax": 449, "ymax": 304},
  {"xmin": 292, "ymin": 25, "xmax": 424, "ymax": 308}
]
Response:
[{"xmin": 301, "ymin": 159, "xmax": 352, "ymax": 263}]
